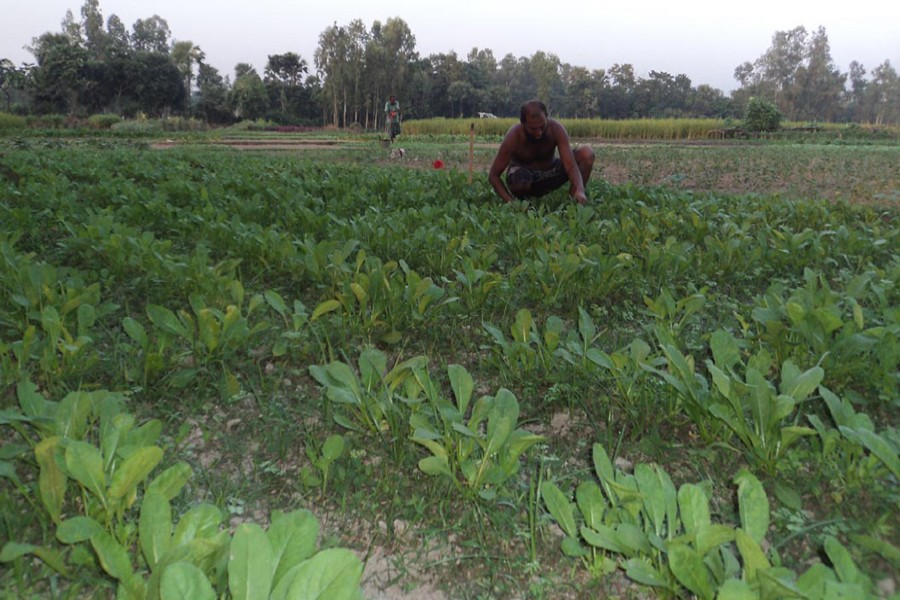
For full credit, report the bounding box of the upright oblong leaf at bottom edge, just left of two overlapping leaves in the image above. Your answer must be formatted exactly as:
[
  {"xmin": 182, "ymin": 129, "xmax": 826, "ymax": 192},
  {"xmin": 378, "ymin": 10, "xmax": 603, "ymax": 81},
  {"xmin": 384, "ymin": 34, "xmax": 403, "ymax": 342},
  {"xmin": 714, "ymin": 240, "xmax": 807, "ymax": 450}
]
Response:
[{"xmin": 228, "ymin": 523, "xmax": 275, "ymax": 600}]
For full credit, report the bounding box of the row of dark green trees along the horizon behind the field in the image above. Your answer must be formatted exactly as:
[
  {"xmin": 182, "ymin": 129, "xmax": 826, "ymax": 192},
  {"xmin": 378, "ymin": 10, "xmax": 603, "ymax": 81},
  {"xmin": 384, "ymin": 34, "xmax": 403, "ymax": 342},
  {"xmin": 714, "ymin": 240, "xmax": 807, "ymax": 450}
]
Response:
[{"xmin": 0, "ymin": 0, "xmax": 900, "ymax": 129}]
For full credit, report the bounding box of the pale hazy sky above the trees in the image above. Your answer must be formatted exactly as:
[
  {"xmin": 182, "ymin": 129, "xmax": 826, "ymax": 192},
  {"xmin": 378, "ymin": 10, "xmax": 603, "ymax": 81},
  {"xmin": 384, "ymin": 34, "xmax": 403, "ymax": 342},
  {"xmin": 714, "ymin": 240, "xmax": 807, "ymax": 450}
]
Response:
[{"xmin": 0, "ymin": 0, "xmax": 900, "ymax": 94}]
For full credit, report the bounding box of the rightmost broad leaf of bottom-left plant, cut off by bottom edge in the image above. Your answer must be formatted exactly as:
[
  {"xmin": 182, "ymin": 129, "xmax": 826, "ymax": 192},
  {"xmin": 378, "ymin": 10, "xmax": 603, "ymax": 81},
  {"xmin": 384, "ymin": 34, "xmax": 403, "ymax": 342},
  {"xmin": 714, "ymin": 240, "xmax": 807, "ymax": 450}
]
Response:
[{"xmin": 286, "ymin": 548, "xmax": 363, "ymax": 600}]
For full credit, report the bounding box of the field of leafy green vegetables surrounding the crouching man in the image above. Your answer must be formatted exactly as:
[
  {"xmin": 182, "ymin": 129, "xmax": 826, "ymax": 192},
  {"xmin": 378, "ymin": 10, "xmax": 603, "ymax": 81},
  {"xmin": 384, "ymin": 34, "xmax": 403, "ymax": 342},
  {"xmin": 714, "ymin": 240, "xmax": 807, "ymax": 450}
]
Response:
[{"xmin": 0, "ymin": 137, "xmax": 900, "ymax": 600}]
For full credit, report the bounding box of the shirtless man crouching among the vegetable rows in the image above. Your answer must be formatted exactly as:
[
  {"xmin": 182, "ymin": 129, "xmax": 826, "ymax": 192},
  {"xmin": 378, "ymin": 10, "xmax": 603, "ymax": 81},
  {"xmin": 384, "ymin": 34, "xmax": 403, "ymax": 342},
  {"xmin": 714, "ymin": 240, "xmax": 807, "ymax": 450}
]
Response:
[{"xmin": 488, "ymin": 100, "xmax": 594, "ymax": 204}]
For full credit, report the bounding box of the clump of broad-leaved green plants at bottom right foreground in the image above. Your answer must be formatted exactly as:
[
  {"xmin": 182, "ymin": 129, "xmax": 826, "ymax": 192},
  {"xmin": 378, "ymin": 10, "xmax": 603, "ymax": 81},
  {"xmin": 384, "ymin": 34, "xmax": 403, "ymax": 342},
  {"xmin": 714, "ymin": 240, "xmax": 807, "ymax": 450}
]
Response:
[{"xmin": 541, "ymin": 444, "xmax": 875, "ymax": 600}]
